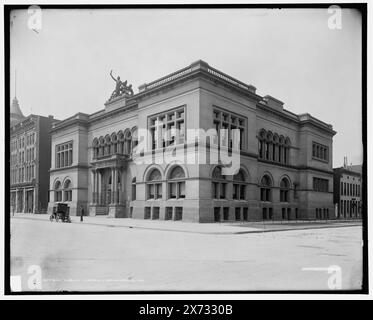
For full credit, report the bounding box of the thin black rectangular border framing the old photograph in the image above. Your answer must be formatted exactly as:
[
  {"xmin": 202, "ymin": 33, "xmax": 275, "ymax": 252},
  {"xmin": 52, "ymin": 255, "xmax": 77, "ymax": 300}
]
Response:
[{"xmin": 3, "ymin": 3, "xmax": 369, "ymax": 302}]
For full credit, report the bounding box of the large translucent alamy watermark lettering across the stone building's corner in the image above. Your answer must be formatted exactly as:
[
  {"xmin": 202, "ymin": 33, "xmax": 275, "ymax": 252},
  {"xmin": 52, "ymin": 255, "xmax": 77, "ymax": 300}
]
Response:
[{"xmin": 132, "ymin": 122, "xmax": 242, "ymax": 175}]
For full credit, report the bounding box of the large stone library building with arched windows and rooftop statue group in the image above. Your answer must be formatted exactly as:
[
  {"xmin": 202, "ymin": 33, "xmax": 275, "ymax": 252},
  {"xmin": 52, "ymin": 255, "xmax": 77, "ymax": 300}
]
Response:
[{"xmin": 48, "ymin": 60, "xmax": 336, "ymax": 222}]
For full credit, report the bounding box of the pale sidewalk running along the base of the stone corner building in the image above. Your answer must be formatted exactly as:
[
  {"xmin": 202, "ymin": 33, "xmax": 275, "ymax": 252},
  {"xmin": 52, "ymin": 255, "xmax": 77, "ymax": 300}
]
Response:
[{"xmin": 11, "ymin": 213, "xmax": 362, "ymax": 235}]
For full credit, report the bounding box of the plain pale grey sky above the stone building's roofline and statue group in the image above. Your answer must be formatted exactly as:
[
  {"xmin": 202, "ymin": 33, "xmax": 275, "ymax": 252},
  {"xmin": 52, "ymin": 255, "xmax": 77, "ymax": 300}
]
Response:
[{"xmin": 10, "ymin": 9, "xmax": 363, "ymax": 167}]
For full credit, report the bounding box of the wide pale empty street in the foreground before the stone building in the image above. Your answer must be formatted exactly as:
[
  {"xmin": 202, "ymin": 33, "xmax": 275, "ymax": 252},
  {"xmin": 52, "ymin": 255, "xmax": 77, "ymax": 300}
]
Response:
[{"xmin": 11, "ymin": 216, "xmax": 362, "ymax": 291}]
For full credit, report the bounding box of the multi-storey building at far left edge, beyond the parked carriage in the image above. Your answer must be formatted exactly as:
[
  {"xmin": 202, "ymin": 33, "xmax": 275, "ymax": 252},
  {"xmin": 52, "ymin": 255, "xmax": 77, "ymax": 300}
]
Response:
[{"xmin": 10, "ymin": 98, "xmax": 54, "ymax": 213}]
